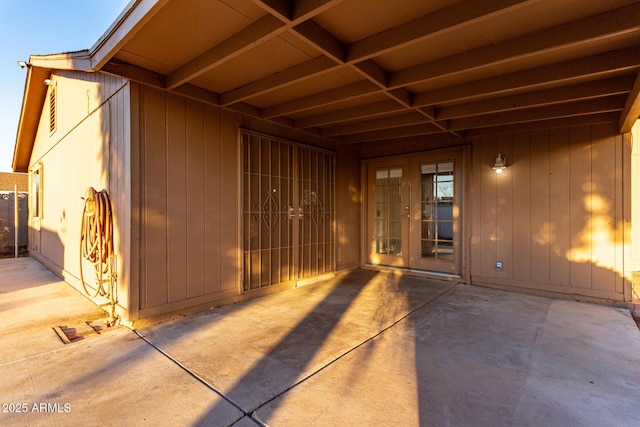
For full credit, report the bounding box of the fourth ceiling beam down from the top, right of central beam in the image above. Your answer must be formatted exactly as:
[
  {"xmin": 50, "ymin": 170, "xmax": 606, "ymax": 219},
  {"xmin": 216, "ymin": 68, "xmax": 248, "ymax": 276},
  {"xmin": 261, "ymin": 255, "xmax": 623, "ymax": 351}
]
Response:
[{"xmin": 436, "ymin": 76, "xmax": 633, "ymax": 120}]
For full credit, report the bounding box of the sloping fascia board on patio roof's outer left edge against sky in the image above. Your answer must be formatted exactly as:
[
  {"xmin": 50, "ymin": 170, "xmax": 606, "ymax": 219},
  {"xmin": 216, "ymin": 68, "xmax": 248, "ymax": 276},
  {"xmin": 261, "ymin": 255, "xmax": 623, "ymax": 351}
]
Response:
[{"xmin": 89, "ymin": 0, "xmax": 169, "ymax": 70}]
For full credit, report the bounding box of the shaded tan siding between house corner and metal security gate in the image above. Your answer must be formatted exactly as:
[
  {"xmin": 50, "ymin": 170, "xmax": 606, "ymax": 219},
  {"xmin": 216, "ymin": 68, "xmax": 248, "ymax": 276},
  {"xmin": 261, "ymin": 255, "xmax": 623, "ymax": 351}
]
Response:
[{"xmin": 132, "ymin": 84, "xmax": 240, "ymax": 318}]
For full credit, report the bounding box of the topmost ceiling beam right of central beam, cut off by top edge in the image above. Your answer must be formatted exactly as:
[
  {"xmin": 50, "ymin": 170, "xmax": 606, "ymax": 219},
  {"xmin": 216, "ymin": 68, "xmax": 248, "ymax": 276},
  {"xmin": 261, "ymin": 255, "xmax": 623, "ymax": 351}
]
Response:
[{"xmin": 347, "ymin": 0, "xmax": 532, "ymax": 62}]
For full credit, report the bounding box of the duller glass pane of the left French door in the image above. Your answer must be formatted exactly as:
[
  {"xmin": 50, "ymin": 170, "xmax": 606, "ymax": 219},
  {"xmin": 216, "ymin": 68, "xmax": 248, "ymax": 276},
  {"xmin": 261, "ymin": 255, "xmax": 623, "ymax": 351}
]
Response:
[{"xmin": 373, "ymin": 168, "xmax": 402, "ymax": 256}]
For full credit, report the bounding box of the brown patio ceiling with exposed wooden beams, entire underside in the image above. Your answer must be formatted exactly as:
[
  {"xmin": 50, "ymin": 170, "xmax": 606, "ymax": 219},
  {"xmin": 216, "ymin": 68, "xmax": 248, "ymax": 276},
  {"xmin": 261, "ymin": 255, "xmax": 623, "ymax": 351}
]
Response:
[{"xmin": 56, "ymin": 0, "xmax": 640, "ymax": 144}]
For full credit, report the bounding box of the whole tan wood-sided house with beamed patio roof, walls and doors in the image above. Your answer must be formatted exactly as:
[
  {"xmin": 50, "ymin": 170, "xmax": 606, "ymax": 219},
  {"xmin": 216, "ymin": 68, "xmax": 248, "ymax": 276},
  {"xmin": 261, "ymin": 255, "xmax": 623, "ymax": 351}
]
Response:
[{"xmin": 13, "ymin": 0, "xmax": 640, "ymax": 327}]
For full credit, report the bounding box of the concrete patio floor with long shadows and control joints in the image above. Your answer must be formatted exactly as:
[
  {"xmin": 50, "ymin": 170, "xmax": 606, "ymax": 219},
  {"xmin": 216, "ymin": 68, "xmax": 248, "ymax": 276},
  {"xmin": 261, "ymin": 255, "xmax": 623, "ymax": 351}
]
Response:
[{"xmin": 0, "ymin": 258, "xmax": 640, "ymax": 426}]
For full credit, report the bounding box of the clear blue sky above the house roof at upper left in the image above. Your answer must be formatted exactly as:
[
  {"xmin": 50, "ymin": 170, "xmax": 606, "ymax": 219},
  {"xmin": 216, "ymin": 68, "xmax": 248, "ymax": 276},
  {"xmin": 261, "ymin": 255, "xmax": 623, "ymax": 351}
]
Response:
[{"xmin": 0, "ymin": 0, "xmax": 129, "ymax": 172}]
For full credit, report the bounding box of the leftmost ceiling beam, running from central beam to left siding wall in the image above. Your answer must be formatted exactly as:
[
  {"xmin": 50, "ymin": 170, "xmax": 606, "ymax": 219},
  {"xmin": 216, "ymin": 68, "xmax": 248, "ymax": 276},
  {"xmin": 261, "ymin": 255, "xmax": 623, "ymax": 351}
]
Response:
[{"xmin": 166, "ymin": 15, "xmax": 286, "ymax": 89}]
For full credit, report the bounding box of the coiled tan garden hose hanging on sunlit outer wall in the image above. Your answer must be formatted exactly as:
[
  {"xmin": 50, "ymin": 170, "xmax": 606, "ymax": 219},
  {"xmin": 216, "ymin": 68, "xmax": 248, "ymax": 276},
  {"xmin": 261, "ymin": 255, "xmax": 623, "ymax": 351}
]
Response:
[{"xmin": 80, "ymin": 187, "xmax": 117, "ymax": 323}]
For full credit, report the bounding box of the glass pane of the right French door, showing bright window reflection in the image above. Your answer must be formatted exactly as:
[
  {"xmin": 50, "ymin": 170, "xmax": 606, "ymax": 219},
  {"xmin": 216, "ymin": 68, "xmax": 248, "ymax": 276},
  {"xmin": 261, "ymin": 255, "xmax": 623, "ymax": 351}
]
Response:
[{"xmin": 420, "ymin": 162, "xmax": 455, "ymax": 261}]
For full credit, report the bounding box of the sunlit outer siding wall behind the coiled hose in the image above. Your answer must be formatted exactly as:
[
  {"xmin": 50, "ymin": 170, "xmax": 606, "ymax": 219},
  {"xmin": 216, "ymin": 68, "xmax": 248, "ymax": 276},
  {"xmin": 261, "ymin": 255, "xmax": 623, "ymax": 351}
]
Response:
[{"xmin": 29, "ymin": 71, "xmax": 130, "ymax": 317}]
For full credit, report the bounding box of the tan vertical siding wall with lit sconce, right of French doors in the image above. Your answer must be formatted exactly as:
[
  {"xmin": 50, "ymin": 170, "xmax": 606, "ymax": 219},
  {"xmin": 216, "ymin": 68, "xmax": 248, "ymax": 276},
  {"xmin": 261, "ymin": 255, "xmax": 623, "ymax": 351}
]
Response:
[{"xmin": 471, "ymin": 124, "xmax": 631, "ymax": 300}]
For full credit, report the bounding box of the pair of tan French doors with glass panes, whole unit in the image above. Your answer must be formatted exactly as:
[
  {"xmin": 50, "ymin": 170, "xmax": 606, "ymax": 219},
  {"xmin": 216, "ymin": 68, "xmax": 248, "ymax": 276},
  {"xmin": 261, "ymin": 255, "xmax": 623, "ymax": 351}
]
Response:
[{"xmin": 367, "ymin": 151, "xmax": 463, "ymax": 274}]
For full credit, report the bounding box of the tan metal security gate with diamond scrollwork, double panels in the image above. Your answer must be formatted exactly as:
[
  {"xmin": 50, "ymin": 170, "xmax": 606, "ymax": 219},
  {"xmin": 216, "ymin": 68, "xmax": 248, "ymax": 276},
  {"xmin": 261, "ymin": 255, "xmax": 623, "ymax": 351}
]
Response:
[{"xmin": 241, "ymin": 131, "xmax": 335, "ymax": 291}]
